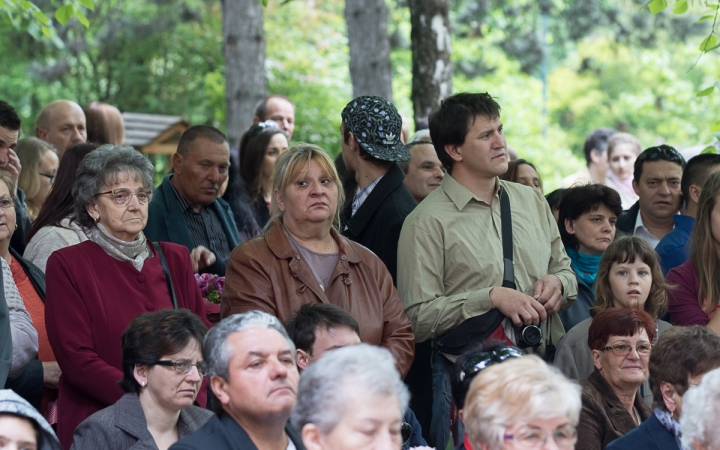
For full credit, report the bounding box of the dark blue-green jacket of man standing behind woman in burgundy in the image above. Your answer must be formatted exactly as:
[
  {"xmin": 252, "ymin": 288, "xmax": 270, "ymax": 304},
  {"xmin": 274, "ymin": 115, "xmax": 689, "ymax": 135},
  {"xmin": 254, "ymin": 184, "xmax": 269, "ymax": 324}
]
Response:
[{"xmin": 143, "ymin": 175, "xmax": 241, "ymax": 276}]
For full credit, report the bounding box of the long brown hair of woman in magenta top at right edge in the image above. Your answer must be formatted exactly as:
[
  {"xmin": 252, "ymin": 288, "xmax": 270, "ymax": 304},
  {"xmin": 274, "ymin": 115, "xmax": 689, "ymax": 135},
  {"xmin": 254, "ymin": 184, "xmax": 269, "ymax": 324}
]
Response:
[{"xmin": 690, "ymin": 172, "xmax": 720, "ymax": 314}]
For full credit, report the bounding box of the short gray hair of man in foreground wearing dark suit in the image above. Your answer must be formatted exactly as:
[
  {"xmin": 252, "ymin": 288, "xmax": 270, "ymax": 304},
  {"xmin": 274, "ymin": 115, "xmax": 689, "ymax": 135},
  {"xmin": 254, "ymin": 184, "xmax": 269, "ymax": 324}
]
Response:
[{"xmin": 203, "ymin": 310, "xmax": 295, "ymax": 380}]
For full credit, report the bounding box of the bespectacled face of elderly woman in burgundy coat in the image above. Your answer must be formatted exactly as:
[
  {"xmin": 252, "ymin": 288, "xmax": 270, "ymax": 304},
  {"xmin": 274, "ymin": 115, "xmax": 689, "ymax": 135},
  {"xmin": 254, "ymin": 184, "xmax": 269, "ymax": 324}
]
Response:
[{"xmin": 87, "ymin": 172, "xmax": 149, "ymax": 242}]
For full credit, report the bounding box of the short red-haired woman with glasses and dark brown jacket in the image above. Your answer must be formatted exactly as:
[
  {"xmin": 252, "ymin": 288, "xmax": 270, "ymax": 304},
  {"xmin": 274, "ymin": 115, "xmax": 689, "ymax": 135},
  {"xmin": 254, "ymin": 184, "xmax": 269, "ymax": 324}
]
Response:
[{"xmin": 578, "ymin": 308, "xmax": 656, "ymax": 450}]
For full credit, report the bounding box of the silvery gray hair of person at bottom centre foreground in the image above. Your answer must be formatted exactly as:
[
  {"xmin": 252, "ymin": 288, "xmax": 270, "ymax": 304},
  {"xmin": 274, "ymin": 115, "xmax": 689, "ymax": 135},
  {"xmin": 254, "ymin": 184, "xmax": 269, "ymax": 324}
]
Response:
[{"xmin": 291, "ymin": 344, "xmax": 410, "ymax": 434}]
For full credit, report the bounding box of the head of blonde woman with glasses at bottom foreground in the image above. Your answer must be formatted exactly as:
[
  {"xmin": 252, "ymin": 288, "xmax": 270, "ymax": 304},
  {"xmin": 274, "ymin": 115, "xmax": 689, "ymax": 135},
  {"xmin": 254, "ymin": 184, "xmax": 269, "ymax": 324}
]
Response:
[{"xmin": 463, "ymin": 355, "xmax": 580, "ymax": 450}]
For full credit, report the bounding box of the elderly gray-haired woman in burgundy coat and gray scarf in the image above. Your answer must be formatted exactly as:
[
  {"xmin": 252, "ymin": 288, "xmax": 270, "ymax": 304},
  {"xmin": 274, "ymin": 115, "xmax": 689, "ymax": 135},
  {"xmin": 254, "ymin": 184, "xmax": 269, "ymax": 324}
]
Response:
[{"xmin": 45, "ymin": 145, "xmax": 209, "ymax": 449}]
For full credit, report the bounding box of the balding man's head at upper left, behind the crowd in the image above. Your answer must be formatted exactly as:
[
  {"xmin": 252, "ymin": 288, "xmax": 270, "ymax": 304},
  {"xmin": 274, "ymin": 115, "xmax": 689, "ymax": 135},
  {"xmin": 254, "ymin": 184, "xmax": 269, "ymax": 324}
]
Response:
[{"xmin": 35, "ymin": 100, "xmax": 87, "ymax": 158}]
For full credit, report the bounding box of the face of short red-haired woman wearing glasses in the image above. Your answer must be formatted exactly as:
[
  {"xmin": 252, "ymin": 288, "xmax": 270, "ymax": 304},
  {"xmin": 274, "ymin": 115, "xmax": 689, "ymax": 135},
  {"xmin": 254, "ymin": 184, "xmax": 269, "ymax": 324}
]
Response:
[{"xmin": 592, "ymin": 328, "xmax": 652, "ymax": 389}]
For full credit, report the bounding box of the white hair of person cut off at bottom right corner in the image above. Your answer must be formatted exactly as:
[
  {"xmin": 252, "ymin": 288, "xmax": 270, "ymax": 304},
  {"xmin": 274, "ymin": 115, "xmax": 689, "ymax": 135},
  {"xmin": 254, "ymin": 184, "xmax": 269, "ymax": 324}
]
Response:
[{"xmin": 680, "ymin": 369, "xmax": 720, "ymax": 449}]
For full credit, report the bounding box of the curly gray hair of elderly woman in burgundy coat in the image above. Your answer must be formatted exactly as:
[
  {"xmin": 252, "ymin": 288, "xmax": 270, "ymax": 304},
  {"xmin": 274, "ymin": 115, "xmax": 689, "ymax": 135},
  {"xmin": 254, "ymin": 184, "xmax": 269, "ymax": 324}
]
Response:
[{"xmin": 72, "ymin": 144, "xmax": 155, "ymax": 228}]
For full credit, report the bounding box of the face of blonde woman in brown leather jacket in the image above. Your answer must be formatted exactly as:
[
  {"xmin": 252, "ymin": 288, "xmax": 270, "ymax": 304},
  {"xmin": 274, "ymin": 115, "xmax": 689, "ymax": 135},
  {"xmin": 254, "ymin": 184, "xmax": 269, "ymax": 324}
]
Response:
[{"xmin": 275, "ymin": 160, "xmax": 338, "ymax": 228}]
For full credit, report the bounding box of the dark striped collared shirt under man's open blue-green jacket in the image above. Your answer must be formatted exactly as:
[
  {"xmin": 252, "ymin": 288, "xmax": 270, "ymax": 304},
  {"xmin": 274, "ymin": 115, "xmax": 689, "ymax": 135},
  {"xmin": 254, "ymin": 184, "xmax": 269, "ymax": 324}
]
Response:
[{"xmin": 169, "ymin": 178, "xmax": 232, "ymax": 276}]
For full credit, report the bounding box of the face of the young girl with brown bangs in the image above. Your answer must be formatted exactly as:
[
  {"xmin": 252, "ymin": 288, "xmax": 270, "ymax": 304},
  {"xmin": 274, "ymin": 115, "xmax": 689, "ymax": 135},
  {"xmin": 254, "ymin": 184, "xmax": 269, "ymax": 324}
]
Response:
[{"xmin": 609, "ymin": 257, "xmax": 652, "ymax": 309}]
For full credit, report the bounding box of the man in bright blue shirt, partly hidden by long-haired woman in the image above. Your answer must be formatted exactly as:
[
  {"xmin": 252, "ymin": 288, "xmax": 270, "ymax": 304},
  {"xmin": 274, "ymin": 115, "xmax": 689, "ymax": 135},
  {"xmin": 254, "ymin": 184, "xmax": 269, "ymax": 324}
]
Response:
[{"xmin": 655, "ymin": 154, "xmax": 720, "ymax": 275}]
